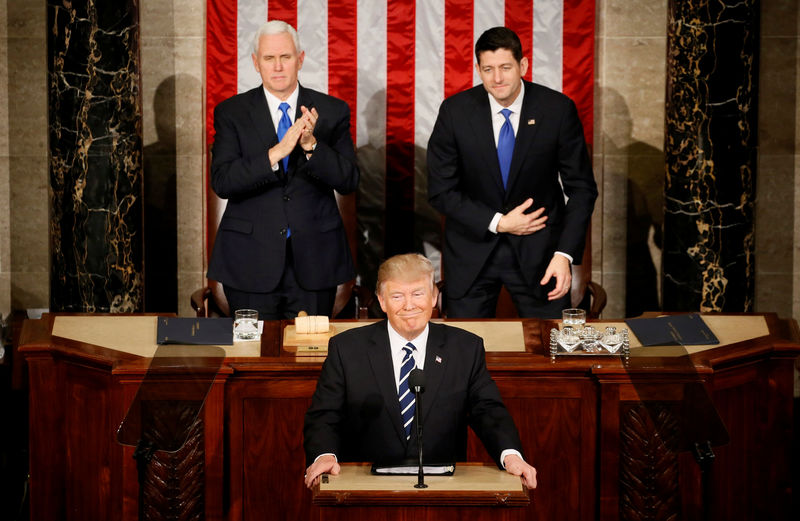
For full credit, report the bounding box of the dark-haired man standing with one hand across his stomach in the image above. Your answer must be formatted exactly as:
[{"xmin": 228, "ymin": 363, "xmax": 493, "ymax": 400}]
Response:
[{"xmin": 428, "ymin": 27, "xmax": 597, "ymax": 317}]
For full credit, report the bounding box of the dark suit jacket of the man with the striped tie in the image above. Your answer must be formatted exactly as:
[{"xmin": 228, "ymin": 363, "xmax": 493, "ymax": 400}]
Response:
[{"xmin": 304, "ymin": 320, "xmax": 522, "ymax": 466}]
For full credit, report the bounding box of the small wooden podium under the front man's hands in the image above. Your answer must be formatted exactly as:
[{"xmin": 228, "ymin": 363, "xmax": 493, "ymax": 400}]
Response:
[{"xmin": 312, "ymin": 463, "xmax": 530, "ymax": 521}]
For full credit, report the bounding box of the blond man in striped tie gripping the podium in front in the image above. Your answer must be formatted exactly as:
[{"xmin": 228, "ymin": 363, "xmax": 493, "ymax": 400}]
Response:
[{"xmin": 304, "ymin": 253, "xmax": 536, "ymax": 488}]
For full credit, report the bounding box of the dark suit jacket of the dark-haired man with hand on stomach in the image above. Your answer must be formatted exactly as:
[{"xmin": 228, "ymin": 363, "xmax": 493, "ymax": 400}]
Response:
[{"xmin": 428, "ymin": 82, "xmax": 597, "ymax": 300}]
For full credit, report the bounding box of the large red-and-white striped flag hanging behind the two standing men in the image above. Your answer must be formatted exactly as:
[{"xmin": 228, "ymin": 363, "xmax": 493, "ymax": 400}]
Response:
[{"xmin": 206, "ymin": 0, "xmax": 595, "ymax": 282}]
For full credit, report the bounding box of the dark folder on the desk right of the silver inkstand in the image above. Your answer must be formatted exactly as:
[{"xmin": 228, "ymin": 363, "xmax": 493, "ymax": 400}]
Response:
[{"xmin": 625, "ymin": 313, "xmax": 719, "ymax": 346}]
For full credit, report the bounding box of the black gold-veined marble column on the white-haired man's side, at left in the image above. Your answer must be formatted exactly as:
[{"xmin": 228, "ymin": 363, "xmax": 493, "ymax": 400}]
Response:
[{"xmin": 47, "ymin": 0, "xmax": 143, "ymax": 312}]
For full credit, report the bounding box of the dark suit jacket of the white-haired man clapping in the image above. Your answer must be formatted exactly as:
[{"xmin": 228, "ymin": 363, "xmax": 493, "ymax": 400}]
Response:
[{"xmin": 208, "ymin": 86, "xmax": 358, "ymax": 293}]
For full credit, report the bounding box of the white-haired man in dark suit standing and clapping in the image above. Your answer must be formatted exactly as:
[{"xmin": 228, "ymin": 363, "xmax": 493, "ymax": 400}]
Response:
[{"xmin": 208, "ymin": 21, "xmax": 358, "ymax": 319}]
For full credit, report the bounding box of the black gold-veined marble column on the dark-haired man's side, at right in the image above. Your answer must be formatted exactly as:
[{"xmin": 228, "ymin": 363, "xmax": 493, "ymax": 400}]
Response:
[{"xmin": 663, "ymin": 0, "xmax": 759, "ymax": 311}]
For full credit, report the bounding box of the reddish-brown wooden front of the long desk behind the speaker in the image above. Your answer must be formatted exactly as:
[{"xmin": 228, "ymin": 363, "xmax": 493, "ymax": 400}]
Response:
[{"xmin": 20, "ymin": 314, "xmax": 800, "ymax": 521}]
